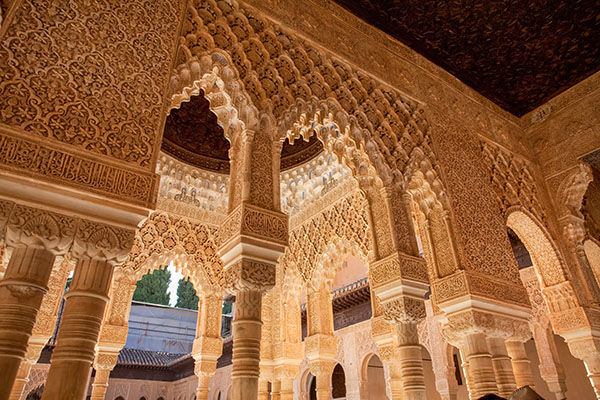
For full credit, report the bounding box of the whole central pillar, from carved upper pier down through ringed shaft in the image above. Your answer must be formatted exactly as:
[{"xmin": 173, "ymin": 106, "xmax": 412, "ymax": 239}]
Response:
[{"xmin": 218, "ymin": 125, "xmax": 288, "ymax": 400}]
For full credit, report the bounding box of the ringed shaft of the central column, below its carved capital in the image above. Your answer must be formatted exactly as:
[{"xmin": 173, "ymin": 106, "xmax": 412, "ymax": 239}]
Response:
[{"xmin": 231, "ymin": 289, "xmax": 262, "ymax": 400}]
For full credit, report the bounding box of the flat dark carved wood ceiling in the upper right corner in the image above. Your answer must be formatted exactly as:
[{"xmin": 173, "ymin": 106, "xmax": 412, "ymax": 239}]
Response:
[{"xmin": 334, "ymin": 0, "xmax": 600, "ymax": 116}]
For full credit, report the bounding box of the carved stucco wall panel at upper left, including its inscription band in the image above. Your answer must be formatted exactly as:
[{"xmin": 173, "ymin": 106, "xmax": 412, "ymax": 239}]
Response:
[{"xmin": 0, "ymin": 0, "xmax": 185, "ymax": 205}]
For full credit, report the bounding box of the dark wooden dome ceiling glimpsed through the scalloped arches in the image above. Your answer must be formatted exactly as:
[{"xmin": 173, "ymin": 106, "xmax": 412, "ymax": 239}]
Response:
[{"xmin": 162, "ymin": 93, "xmax": 323, "ymax": 173}]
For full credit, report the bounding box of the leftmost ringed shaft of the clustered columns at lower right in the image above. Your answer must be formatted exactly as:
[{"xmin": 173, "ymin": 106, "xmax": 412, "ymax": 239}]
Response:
[{"xmin": 461, "ymin": 333, "xmax": 498, "ymax": 399}]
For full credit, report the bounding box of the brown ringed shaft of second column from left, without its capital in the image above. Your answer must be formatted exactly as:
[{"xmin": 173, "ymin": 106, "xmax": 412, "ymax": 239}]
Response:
[{"xmin": 42, "ymin": 259, "xmax": 113, "ymax": 400}]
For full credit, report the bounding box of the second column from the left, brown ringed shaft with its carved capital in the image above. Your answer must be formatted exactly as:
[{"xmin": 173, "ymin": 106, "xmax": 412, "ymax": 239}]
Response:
[{"xmin": 42, "ymin": 220, "xmax": 134, "ymax": 400}]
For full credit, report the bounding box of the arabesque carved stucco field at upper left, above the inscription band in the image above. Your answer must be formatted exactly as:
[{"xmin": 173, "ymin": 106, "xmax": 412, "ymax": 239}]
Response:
[{"xmin": 0, "ymin": 1, "xmax": 183, "ymax": 168}]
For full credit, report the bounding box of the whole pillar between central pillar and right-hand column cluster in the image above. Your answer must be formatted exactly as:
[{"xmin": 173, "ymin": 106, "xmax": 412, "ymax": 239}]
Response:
[{"xmin": 363, "ymin": 186, "xmax": 428, "ymax": 400}]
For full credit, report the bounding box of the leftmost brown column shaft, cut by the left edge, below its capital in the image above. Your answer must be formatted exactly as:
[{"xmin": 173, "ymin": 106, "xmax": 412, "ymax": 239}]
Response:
[{"xmin": 0, "ymin": 246, "xmax": 54, "ymax": 399}]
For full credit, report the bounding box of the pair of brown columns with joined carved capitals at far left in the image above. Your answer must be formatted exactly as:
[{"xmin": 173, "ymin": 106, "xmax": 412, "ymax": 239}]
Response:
[{"xmin": 0, "ymin": 201, "xmax": 134, "ymax": 399}]
